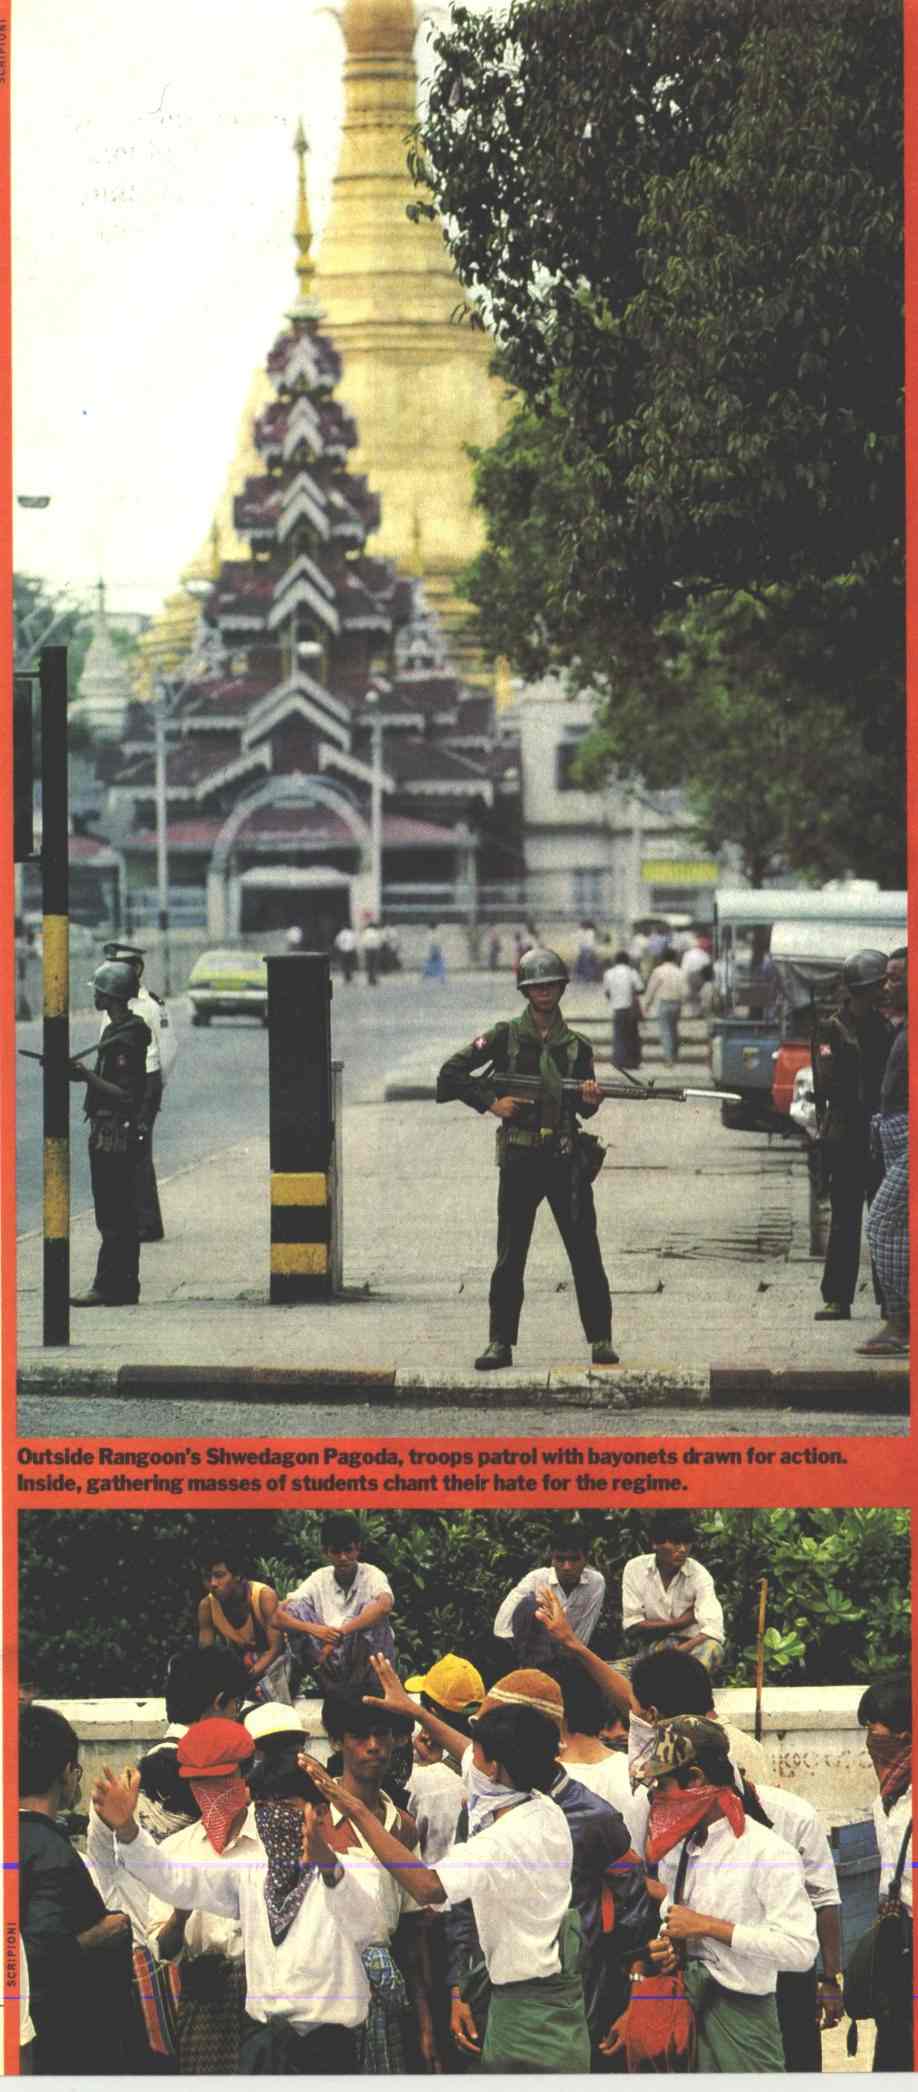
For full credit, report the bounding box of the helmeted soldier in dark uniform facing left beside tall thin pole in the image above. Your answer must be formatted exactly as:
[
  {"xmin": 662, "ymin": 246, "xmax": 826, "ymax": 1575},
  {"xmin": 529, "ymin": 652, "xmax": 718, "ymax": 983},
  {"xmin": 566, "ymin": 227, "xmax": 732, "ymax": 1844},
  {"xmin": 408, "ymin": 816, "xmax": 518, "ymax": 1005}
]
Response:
[{"xmin": 69, "ymin": 960, "xmax": 151, "ymax": 1308}]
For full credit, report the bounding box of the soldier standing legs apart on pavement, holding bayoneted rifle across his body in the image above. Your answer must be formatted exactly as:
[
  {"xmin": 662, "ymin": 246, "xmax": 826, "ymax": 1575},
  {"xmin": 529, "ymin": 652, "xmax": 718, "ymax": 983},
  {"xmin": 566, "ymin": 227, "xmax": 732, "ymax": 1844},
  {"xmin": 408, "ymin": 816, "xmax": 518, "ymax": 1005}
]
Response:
[{"xmin": 437, "ymin": 946, "xmax": 619, "ymax": 1372}]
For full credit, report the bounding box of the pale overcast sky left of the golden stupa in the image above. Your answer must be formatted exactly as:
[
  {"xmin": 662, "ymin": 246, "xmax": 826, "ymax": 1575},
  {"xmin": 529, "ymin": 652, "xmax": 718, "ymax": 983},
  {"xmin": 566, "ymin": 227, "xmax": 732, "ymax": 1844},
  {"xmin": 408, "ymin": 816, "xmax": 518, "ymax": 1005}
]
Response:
[{"xmin": 13, "ymin": 0, "xmax": 487, "ymax": 611}]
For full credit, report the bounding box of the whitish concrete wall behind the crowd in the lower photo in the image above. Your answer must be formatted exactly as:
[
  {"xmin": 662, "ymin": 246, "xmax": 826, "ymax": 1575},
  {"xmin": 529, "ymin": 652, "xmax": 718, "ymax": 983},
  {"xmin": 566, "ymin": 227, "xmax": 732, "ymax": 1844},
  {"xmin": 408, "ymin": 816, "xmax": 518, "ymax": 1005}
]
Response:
[{"xmin": 50, "ymin": 1684, "xmax": 876, "ymax": 1828}]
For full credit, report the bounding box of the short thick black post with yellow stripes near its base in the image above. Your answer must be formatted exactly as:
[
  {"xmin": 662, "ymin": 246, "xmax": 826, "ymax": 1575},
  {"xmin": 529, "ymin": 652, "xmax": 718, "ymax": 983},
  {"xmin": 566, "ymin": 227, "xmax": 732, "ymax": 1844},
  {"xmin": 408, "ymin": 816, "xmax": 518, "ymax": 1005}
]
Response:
[{"xmin": 268, "ymin": 952, "xmax": 332, "ymax": 1303}]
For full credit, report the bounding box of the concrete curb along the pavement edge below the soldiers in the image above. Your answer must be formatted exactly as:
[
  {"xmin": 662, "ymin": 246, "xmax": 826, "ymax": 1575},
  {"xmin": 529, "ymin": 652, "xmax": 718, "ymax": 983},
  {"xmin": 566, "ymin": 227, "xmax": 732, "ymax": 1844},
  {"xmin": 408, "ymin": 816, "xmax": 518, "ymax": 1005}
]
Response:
[{"xmin": 19, "ymin": 1356, "xmax": 908, "ymax": 1427}]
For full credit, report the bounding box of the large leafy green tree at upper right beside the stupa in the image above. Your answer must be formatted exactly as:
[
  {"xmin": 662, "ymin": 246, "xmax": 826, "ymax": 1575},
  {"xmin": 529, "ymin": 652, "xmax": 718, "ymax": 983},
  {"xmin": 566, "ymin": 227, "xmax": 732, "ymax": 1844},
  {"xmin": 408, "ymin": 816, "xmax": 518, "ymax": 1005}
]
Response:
[{"xmin": 416, "ymin": 0, "xmax": 903, "ymax": 877}]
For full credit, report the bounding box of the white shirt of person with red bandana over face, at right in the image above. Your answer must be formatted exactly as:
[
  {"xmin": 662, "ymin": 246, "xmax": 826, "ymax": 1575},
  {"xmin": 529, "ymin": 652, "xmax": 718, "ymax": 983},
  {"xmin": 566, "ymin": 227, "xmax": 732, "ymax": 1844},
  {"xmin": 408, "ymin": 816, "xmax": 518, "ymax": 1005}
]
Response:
[{"xmin": 659, "ymin": 1816, "xmax": 820, "ymax": 1998}]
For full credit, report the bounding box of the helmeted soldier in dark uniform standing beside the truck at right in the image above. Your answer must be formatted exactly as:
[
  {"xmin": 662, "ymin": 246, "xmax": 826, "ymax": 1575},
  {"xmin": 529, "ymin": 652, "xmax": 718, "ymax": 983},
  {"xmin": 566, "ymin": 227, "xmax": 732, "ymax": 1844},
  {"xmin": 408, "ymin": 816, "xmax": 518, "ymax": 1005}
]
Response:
[{"xmin": 811, "ymin": 950, "xmax": 893, "ymax": 1322}]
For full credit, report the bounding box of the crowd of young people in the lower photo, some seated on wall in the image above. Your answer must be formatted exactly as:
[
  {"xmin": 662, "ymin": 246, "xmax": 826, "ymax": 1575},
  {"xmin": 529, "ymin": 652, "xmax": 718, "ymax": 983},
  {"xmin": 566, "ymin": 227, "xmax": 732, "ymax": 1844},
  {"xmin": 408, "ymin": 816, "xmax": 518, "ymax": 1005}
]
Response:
[{"xmin": 19, "ymin": 1510, "xmax": 912, "ymax": 2077}]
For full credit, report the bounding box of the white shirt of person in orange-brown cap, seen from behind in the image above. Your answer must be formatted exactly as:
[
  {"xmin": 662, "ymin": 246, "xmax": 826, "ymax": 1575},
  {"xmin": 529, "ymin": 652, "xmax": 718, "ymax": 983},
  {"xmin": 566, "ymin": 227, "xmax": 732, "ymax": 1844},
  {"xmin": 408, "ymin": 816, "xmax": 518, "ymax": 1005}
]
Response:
[{"xmin": 437, "ymin": 1795, "xmax": 573, "ymax": 1983}]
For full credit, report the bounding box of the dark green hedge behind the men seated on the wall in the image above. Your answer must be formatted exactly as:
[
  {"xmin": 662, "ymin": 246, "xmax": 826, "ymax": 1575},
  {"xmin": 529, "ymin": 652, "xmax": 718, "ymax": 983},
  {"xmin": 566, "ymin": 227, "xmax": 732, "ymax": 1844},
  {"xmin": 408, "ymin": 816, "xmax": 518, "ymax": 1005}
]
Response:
[{"xmin": 19, "ymin": 1508, "xmax": 910, "ymax": 1699}]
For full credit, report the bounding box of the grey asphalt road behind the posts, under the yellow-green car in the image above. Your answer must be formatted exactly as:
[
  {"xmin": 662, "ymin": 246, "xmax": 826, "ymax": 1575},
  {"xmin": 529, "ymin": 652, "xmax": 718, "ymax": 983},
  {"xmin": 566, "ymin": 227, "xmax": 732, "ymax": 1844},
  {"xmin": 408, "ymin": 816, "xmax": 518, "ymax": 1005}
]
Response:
[{"xmin": 17, "ymin": 973, "xmax": 514, "ymax": 1234}]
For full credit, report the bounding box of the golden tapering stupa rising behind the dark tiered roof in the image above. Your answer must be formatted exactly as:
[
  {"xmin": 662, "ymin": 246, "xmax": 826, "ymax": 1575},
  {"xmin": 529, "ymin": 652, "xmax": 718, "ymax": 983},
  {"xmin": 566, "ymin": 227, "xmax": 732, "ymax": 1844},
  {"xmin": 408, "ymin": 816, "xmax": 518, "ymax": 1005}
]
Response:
[{"xmin": 316, "ymin": 0, "xmax": 506, "ymax": 632}]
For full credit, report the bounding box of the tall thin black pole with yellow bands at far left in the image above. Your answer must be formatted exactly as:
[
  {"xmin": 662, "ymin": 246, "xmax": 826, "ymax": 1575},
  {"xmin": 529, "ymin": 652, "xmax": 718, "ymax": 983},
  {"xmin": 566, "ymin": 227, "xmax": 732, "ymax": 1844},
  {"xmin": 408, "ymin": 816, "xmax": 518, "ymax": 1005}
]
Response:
[{"xmin": 40, "ymin": 646, "xmax": 71, "ymax": 1343}]
